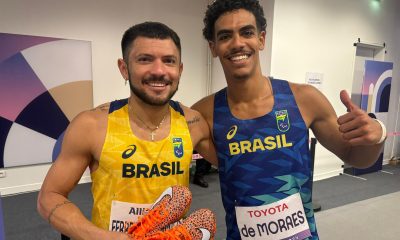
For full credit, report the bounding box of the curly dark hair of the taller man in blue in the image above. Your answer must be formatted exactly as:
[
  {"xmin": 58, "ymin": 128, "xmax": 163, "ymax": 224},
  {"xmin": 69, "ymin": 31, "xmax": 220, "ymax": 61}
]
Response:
[{"xmin": 203, "ymin": 0, "xmax": 267, "ymax": 41}]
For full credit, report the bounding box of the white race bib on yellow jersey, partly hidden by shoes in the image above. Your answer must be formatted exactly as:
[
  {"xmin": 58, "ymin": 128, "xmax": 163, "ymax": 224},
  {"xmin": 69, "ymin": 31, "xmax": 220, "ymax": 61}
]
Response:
[{"xmin": 109, "ymin": 200, "xmax": 151, "ymax": 232}]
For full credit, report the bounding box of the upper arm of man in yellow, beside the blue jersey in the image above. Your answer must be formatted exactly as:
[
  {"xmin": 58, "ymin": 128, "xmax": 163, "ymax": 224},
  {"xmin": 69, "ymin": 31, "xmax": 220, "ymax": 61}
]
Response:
[{"xmin": 183, "ymin": 101, "xmax": 218, "ymax": 166}]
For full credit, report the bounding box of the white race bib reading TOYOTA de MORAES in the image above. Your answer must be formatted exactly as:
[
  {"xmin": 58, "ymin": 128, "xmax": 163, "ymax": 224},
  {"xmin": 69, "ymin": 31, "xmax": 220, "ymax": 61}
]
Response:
[{"xmin": 236, "ymin": 193, "xmax": 311, "ymax": 240}]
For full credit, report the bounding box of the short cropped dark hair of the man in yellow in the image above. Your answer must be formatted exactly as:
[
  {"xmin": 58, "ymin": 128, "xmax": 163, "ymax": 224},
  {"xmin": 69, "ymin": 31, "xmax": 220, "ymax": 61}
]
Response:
[{"xmin": 121, "ymin": 22, "xmax": 181, "ymax": 62}]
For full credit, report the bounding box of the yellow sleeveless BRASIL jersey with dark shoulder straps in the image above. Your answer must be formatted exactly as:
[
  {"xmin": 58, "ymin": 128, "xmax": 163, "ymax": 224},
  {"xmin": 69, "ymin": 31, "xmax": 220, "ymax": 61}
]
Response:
[{"xmin": 91, "ymin": 99, "xmax": 193, "ymax": 232}]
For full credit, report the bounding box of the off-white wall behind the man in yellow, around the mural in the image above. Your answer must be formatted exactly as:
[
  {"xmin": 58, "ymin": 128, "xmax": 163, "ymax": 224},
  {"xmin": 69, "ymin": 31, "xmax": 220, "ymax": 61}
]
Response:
[{"xmin": 0, "ymin": 0, "xmax": 207, "ymax": 195}]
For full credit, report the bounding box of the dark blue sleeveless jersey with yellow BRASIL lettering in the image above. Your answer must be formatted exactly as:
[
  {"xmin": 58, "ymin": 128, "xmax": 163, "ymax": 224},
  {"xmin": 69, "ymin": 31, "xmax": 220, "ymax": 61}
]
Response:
[{"xmin": 213, "ymin": 79, "xmax": 318, "ymax": 240}]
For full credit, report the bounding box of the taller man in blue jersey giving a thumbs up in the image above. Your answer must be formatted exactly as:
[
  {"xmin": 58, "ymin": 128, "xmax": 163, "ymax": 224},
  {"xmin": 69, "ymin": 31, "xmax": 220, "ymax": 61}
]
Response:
[{"xmin": 193, "ymin": 0, "xmax": 386, "ymax": 240}]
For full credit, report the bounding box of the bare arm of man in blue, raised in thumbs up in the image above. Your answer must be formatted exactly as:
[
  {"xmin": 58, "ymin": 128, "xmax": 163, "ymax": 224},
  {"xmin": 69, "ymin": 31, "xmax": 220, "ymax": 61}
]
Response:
[{"xmin": 292, "ymin": 84, "xmax": 383, "ymax": 168}]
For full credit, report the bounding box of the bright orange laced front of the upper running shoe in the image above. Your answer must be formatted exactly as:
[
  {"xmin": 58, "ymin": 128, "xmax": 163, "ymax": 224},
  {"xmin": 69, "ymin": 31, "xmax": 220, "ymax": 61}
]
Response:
[{"xmin": 128, "ymin": 203, "xmax": 168, "ymax": 237}]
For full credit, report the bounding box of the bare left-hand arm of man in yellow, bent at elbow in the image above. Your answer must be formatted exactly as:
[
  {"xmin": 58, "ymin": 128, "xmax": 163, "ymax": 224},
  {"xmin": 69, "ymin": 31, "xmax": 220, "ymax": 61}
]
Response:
[{"xmin": 37, "ymin": 111, "xmax": 128, "ymax": 240}]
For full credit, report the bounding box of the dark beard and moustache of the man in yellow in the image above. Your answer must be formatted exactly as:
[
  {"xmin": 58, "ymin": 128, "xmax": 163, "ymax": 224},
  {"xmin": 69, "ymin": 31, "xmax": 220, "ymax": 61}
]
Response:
[{"xmin": 128, "ymin": 71, "xmax": 179, "ymax": 106}]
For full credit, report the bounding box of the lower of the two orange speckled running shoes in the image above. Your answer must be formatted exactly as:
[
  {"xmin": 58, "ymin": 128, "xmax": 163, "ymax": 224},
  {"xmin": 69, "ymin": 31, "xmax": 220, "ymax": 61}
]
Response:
[{"xmin": 144, "ymin": 209, "xmax": 216, "ymax": 240}]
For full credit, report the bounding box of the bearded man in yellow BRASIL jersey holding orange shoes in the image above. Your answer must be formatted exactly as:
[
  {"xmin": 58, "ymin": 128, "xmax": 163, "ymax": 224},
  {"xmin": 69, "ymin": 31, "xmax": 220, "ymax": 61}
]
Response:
[{"xmin": 38, "ymin": 22, "xmax": 216, "ymax": 240}]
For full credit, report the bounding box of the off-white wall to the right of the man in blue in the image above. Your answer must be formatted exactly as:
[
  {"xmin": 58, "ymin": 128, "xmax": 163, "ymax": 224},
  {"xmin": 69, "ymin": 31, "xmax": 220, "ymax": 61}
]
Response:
[{"xmin": 271, "ymin": 0, "xmax": 400, "ymax": 180}]
